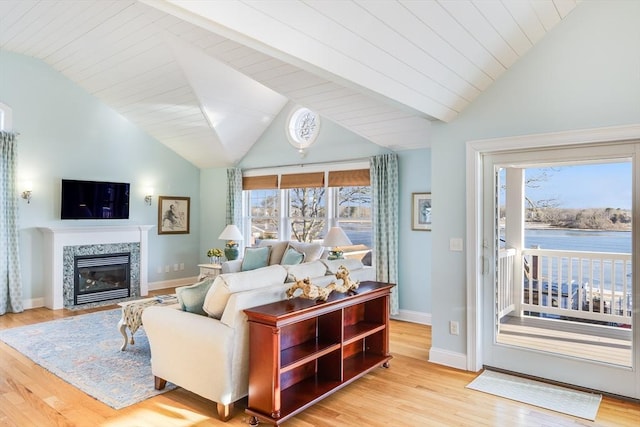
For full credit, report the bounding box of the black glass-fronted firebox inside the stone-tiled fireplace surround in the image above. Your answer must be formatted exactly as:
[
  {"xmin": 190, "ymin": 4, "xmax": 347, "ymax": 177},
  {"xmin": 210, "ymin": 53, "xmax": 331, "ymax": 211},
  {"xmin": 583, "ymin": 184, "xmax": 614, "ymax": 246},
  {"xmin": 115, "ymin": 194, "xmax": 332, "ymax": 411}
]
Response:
[{"xmin": 73, "ymin": 252, "xmax": 131, "ymax": 305}]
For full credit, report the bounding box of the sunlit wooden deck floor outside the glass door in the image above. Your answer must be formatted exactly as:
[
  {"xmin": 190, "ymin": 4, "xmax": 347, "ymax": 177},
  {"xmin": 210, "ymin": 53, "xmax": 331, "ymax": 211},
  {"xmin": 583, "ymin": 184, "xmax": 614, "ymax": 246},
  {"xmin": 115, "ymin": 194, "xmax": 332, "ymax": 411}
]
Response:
[{"xmin": 497, "ymin": 316, "xmax": 632, "ymax": 367}]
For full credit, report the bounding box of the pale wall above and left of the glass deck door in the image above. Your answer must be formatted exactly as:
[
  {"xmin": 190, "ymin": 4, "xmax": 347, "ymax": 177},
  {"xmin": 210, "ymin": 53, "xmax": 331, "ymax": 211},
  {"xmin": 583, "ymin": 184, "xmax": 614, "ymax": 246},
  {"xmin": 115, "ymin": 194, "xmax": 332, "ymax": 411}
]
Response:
[{"xmin": 431, "ymin": 1, "xmax": 640, "ymax": 353}]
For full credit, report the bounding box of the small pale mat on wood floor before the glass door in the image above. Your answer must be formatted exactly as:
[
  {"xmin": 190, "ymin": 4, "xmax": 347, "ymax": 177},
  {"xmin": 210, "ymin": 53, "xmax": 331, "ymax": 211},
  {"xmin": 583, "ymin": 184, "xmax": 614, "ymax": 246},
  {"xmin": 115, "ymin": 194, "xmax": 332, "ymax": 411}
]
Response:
[{"xmin": 467, "ymin": 371, "xmax": 602, "ymax": 421}]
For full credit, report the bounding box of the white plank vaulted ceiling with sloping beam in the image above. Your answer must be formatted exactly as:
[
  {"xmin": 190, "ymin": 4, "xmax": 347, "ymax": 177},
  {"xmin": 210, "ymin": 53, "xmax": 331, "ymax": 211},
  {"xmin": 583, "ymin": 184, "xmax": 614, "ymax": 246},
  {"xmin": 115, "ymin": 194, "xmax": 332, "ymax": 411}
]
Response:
[{"xmin": 0, "ymin": 0, "xmax": 580, "ymax": 168}]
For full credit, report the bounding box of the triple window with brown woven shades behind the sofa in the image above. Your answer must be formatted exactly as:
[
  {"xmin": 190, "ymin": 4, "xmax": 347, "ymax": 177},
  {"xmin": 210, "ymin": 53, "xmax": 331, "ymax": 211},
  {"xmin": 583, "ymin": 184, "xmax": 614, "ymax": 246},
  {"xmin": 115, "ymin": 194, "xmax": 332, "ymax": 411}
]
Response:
[{"xmin": 243, "ymin": 169, "xmax": 373, "ymax": 256}]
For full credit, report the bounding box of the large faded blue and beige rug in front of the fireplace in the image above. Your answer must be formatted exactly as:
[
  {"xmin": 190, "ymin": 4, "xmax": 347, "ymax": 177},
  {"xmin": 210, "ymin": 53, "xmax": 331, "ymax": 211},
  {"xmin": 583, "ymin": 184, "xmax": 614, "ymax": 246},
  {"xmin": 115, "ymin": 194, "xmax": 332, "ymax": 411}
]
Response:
[{"xmin": 0, "ymin": 309, "xmax": 175, "ymax": 409}]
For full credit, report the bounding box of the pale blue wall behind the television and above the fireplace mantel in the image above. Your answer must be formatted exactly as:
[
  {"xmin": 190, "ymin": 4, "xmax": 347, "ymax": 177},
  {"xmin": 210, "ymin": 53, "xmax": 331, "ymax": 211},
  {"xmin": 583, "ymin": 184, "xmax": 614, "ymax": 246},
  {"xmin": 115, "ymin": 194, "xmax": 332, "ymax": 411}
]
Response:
[{"xmin": 0, "ymin": 51, "xmax": 204, "ymax": 304}]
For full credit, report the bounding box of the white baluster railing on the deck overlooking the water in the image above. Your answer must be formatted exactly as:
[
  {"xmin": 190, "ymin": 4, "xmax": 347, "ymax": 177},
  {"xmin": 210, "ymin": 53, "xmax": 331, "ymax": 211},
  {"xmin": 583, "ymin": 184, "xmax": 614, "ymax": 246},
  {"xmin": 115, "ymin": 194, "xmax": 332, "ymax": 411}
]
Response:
[{"xmin": 497, "ymin": 249, "xmax": 632, "ymax": 325}]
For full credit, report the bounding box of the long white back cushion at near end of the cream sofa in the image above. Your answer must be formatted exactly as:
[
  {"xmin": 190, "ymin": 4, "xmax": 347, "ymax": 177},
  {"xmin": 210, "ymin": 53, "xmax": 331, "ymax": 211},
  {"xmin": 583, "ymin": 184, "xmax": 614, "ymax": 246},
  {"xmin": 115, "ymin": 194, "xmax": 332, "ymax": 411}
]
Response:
[{"xmin": 203, "ymin": 265, "xmax": 287, "ymax": 319}]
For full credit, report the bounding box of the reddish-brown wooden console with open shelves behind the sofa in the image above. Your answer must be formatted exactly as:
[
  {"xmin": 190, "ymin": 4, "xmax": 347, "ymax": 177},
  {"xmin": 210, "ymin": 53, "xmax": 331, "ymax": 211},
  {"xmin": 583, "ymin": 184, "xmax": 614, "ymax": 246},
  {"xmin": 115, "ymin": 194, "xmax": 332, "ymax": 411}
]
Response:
[{"xmin": 244, "ymin": 281, "xmax": 395, "ymax": 425}]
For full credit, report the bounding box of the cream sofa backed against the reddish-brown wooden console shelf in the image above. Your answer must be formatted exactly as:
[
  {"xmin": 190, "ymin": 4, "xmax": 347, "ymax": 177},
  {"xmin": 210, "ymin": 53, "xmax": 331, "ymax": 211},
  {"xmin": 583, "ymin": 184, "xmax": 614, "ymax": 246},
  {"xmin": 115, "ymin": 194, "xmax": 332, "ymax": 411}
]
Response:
[{"xmin": 142, "ymin": 260, "xmax": 375, "ymax": 421}]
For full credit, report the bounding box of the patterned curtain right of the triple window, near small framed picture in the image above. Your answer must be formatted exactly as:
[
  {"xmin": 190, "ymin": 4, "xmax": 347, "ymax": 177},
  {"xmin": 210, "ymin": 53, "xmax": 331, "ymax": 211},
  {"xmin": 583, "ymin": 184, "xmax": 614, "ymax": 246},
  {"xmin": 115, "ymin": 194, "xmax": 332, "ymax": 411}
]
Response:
[{"xmin": 370, "ymin": 154, "xmax": 399, "ymax": 314}]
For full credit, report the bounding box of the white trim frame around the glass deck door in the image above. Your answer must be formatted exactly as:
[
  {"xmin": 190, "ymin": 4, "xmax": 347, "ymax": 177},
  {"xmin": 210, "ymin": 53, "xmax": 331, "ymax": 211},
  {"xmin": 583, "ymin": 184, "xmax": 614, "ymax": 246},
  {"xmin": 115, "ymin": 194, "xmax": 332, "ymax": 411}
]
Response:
[{"xmin": 466, "ymin": 124, "xmax": 640, "ymax": 372}]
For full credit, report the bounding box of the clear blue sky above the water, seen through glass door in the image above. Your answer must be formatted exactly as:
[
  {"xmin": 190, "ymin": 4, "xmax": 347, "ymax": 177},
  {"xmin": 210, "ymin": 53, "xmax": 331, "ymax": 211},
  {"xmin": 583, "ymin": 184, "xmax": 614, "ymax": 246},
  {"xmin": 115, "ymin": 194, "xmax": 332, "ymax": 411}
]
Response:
[{"xmin": 525, "ymin": 162, "xmax": 632, "ymax": 209}]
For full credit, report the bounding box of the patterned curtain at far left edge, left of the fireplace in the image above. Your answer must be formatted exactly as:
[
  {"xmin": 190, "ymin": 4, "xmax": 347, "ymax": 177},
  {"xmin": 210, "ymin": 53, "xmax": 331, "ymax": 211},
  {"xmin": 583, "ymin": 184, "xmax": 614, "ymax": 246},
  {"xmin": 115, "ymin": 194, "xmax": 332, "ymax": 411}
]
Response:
[{"xmin": 0, "ymin": 131, "xmax": 24, "ymax": 315}]
